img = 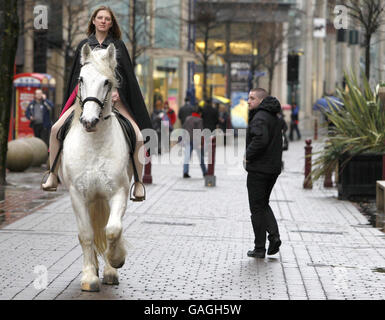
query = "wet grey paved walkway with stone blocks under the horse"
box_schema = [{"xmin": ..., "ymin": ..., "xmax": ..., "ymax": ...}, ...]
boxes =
[{"xmin": 0, "ymin": 134, "xmax": 385, "ymax": 300}]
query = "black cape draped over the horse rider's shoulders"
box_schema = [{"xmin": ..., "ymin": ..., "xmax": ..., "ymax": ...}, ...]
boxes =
[{"xmin": 62, "ymin": 34, "xmax": 152, "ymax": 130}]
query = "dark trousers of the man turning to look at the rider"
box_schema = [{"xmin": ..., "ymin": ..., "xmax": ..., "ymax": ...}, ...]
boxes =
[{"xmin": 247, "ymin": 172, "xmax": 279, "ymax": 251}]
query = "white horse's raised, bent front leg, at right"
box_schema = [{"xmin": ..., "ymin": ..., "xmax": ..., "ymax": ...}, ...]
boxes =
[{"xmin": 106, "ymin": 188, "xmax": 127, "ymax": 268}]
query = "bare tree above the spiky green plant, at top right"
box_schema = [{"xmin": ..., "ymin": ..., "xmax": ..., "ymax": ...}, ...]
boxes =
[{"xmin": 342, "ymin": 0, "xmax": 385, "ymax": 79}]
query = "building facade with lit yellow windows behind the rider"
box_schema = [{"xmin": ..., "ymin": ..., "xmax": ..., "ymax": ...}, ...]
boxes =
[{"xmin": 16, "ymin": 0, "xmax": 385, "ymax": 128}]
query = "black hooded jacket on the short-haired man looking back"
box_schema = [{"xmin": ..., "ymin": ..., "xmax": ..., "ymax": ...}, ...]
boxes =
[{"xmin": 246, "ymin": 97, "xmax": 282, "ymax": 174}]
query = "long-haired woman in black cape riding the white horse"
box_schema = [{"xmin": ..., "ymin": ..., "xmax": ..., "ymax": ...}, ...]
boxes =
[{"xmin": 42, "ymin": 6, "xmax": 152, "ymax": 201}]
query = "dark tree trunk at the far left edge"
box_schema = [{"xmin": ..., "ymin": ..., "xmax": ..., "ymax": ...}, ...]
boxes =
[{"xmin": 0, "ymin": 0, "xmax": 19, "ymax": 185}]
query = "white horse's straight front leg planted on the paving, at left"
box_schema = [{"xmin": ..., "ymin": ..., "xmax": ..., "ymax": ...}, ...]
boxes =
[{"xmin": 69, "ymin": 187, "xmax": 100, "ymax": 291}]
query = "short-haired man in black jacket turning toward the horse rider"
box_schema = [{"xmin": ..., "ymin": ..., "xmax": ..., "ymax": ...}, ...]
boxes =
[{"xmin": 245, "ymin": 89, "xmax": 282, "ymax": 259}]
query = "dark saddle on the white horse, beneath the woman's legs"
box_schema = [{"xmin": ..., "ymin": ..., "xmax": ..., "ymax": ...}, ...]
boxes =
[{"xmin": 50, "ymin": 109, "xmax": 140, "ymax": 183}]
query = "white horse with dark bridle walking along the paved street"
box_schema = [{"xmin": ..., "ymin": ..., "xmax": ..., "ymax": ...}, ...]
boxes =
[{"xmin": 60, "ymin": 44, "xmax": 132, "ymax": 291}]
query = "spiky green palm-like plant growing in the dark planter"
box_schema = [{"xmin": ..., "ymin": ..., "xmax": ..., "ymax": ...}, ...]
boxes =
[{"xmin": 312, "ymin": 74, "xmax": 385, "ymax": 180}]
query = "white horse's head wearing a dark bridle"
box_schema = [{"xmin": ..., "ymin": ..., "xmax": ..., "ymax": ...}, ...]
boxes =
[{"xmin": 79, "ymin": 43, "xmax": 117, "ymax": 132}]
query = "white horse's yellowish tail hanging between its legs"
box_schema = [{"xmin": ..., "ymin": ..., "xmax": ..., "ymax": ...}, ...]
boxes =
[{"xmin": 89, "ymin": 200, "xmax": 110, "ymax": 255}]
